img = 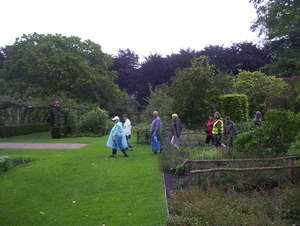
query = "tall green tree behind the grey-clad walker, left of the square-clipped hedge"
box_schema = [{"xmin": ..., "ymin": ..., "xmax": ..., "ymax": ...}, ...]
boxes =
[{"xmin": 170, "ymin": 56, "xmax": 221, "ymax": 126}]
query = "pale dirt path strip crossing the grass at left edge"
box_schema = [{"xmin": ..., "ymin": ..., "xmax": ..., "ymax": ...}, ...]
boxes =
[{"xmin": 0, "ymin": 142, "xmax": 88, "ymax": 149}]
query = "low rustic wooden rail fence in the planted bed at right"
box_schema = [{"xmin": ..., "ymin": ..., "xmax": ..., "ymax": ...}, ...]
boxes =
[{"xmin": 182, "ymin": 156, "xmax": 300, "ymax": 187}]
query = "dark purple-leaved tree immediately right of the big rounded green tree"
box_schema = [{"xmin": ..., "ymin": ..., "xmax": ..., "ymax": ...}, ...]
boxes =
[{"xmin": 109, "ymin": 49, "xmax": 140, "ymax": 95}]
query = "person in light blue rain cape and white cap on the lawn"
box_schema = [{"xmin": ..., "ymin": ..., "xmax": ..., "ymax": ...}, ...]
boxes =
[{"xmin": 106, "ymin": 116, "xmax": 128, "ymax": 157}]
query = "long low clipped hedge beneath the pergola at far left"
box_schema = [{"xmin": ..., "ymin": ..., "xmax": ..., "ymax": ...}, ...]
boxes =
[{"xmin": 0, "ymin": 123, "xmax": 51, "ymax": 138}]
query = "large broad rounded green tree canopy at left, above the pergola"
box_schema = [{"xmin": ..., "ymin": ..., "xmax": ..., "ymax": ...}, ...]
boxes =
[{"xmin": 0, "ymin": 33, "xmax": 120, "ymax": 110}]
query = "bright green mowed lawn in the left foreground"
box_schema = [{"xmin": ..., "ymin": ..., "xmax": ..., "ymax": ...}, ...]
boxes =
[{"xmin": 0, "ymin": 133, "xmax": 166, "ymax": 226}]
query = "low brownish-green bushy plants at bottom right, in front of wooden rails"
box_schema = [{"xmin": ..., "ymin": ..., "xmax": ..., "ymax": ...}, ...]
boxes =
[{"xmin": 166, "ymin": 188, "xmax": 285, "ymax": 226}]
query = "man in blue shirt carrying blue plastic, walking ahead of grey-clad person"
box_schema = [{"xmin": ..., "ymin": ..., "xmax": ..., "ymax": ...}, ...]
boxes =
[{"xmin": 151, "ymin": 111, "xmax": 162, "ymax": 154}]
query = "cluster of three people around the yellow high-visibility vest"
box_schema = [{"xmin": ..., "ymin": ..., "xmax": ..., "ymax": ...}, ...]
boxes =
[{"xmin": 205, "ymin": 112, "xmax": 238, "ymax": 149}]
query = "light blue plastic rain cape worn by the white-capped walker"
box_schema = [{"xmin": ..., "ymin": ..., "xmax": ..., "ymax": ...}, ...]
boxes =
[{"xmin": 106, "ymin": 122, "xmax": 128, "ymax": 150}]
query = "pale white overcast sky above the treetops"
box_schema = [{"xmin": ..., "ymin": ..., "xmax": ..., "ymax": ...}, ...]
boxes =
[{"xmin": 0, "ymin": 0, "xmax": 258, "ymax": 59}]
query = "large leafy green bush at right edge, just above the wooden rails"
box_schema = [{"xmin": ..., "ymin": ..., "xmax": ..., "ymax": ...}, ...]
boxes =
[{"xmin": 235, "ymin": 110, "xmax": 300, "ymax": 157}]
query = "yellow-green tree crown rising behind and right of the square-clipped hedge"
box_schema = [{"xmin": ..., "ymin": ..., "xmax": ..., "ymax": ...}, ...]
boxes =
[{"xmin": 233, "ymin": 71, "xmax": 287, "ymax": 115}]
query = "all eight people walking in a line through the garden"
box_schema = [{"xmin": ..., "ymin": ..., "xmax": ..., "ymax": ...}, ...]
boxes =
[{"xmin": 106, "ymin": 111, "xmax": 262, "ymax": 157}]
